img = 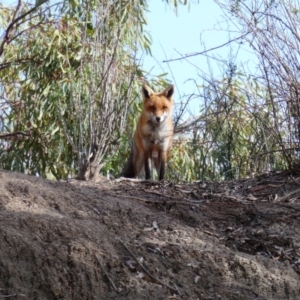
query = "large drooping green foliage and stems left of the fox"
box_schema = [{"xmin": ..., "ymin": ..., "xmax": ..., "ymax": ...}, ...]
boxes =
[{"xmin": 0, "ymin": 1, "xmax": 150, "ymax": 179}]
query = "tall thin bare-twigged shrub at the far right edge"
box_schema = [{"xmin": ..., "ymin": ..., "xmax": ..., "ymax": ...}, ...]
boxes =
[{"xmin": 215, "ymin": 0, "xmax": 300, "ymax": 168}]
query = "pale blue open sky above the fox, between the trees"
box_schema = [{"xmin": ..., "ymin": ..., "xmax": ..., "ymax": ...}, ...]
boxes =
[{"xmin": 143, "ymin": 0, "xmax": 255, "ymax": 114}]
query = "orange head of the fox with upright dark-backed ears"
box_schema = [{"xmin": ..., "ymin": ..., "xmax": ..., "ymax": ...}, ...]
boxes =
[{"xmin": 142, "ymin": 84, "xmax": 174, "ymax": 124}]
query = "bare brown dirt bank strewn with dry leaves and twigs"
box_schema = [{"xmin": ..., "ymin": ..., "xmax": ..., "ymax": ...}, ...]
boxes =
[{"xmin": 0, "ymin": 171, "xmax": 300, "ymax": 300}]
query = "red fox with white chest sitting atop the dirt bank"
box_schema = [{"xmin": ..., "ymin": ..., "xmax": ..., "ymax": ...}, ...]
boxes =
[{"xmin": 122, "ymin": 85, "xmax": 174, "ymax": 180}]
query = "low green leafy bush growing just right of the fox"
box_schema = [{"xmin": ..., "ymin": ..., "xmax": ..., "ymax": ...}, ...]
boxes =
[{"xmin": 168, "ymin": 74, "xmax": 288, "ymax": 181}]
